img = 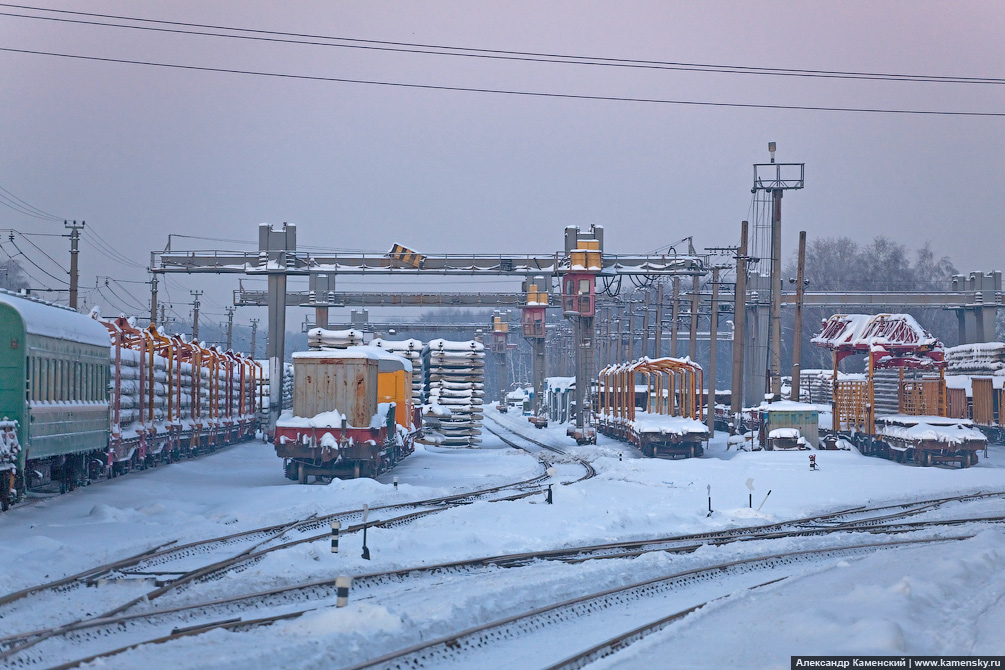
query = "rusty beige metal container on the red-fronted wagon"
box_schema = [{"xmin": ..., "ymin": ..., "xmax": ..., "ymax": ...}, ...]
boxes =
[{"xmin": 293, "ymin": 350, "xmax": 380, "ymax": 428}]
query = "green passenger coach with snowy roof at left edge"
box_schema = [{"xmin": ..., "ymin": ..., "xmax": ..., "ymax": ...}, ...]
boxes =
[{"xmin": 0, "ymin": 291, "xmax": 110, "ymax": 493}]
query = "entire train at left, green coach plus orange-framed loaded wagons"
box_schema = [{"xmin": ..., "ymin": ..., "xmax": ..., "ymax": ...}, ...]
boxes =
[{"xmin": 0, "ymin": 290, "xmax": 260, "ymax": 507}]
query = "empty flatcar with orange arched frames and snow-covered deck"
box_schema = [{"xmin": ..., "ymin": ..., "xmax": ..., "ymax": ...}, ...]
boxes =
[{"xmin": 597, "ymin": 358, "xmax": 709, "ymax": 457}]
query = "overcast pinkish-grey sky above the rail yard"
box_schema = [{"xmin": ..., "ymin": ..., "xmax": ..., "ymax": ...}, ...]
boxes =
[{"xmin": 0, "ymin": 0, "xmax": 1005, "ymax": 323}]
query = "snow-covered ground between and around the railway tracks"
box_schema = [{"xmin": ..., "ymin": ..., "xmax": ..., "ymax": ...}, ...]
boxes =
[{"xmin": 0, "ymin": 411, "xmax": 1005, "ymax": 668}]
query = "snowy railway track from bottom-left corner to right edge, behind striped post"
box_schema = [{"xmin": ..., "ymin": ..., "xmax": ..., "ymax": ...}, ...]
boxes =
[{"xmin": 0, "ymin": 494, "xmax": 1005, "ymax": 667}]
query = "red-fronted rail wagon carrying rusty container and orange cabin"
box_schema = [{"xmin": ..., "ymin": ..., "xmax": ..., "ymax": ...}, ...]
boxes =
[{"xmin": 273, "ymin": 346, "xmax": 420, "ymax": 484}]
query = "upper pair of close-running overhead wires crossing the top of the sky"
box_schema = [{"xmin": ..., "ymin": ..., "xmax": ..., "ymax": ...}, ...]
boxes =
[{"xmin": 0, "ymin": 3, "xmax": 1005, "ymax": 85}]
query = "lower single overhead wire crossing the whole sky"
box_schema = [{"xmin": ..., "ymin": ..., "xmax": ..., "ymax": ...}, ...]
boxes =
[{"xmin": 0, "ymin": 47, "xmax": 1005, "ymax": 118}]
